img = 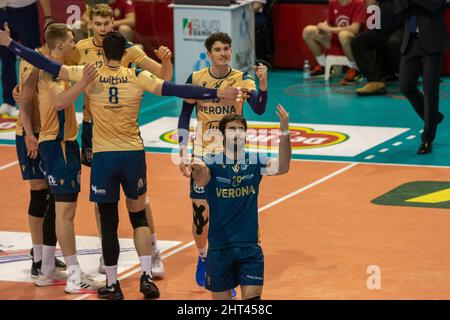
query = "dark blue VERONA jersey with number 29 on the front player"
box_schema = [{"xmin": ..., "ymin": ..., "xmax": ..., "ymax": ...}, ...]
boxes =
[{"xmin": 205, "ymin": 153, "xmax": 265, "ymax": 249}]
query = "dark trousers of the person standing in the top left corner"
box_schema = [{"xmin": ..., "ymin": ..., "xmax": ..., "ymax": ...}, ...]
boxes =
[{"xmin": 0, "ymin": 3, "xmax": 40, "ymax": 105}]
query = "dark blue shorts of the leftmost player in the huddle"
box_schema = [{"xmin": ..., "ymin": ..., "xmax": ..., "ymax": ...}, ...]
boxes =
[{"xmin": 16, "ymin": 133, "xmax": 45, "ymax": 180}]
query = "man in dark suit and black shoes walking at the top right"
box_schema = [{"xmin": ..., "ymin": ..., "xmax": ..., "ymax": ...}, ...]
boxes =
[{"xmin": 395, "ymin": 0, "xmax": 448, "ymax": 154}]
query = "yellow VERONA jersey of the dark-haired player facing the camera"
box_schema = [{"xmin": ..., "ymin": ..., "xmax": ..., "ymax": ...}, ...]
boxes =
[{"xmin": 186, "ymin": 68, "xmax": 256, "ymax": 156}]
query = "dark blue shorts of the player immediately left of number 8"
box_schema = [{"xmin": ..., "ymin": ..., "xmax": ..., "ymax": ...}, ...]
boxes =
[{"xmin": 39, "ymin": 140, "xmax": 81, "ymax": 194}]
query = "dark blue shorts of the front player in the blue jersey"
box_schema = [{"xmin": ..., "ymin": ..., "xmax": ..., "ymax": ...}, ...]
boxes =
[{"xmin": 205, "ymin": 245, "xmax": 264, "ymax": 292}]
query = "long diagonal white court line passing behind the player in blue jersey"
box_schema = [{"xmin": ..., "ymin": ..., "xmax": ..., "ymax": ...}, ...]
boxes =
[{"xmin": 74, "ymin": 163, "xmax": 358, "ymax": 300}]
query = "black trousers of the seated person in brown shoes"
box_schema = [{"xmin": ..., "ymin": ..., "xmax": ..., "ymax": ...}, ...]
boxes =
[{"xmin": 351, "ymin": 26, "xmax": 403, "ymax": 81}]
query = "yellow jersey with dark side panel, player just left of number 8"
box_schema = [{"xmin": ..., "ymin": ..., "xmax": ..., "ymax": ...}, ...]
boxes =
[{"xmin": 38, "ymin": 70, "xmax": 78, "ymax": 142}]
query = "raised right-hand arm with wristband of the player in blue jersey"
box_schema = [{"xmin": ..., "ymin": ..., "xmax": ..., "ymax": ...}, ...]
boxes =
[{"xmin": 265, "ymin": 104, "xmax": 292, "ymax": 176}]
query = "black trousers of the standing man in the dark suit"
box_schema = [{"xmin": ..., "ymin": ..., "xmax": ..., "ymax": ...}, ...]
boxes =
[{"xmin": 400, "ymin": 36, "xmax": 443, "ymax": 142}]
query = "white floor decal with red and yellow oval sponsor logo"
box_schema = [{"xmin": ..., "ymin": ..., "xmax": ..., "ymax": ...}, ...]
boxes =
[{"xmin": 134, "ymin": 117, "xmax": 410, "ymax": 157}]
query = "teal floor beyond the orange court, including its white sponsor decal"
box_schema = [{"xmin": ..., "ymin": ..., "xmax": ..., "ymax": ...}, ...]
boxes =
[{"xmin": 0, "ymin": 70, "xmax": 450, "ymax": 166}]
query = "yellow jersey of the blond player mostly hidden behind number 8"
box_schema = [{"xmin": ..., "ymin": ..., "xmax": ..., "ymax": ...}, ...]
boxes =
[{"xmin": 68, "ymin": 37, "xmax": 147, "ymax": 122}]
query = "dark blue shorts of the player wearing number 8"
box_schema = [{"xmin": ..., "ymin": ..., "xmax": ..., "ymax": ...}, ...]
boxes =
[{"xmin": 90, "ymin": 150, "xmax": 147, "ymax": 203}]
